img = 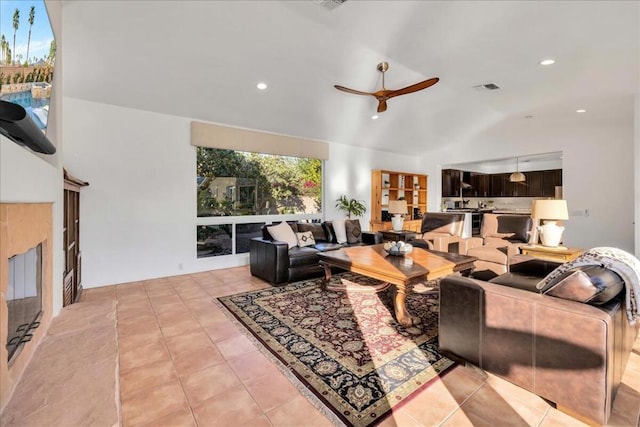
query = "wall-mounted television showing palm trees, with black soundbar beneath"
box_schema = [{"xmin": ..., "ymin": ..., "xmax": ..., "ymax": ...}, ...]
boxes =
[{"xmin": 0, "ymin": 0, "xmax": 56, "ymax": 154}]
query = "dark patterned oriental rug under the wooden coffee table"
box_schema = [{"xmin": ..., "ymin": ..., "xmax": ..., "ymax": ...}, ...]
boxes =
[{"xmin": 218, "ymin": 272, "xmax": 454, "ymax": 426}]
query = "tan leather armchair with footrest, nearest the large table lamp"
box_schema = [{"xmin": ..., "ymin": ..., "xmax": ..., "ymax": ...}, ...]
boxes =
[{"xmin": 459, "ymin": 213, "xmax": 534, "ymax": 280}]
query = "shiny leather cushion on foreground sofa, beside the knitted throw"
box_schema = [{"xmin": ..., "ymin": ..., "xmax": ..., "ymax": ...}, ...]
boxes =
[{"xmin": 543, "ymin": 265, "xmax": 624, "ymax": 305}]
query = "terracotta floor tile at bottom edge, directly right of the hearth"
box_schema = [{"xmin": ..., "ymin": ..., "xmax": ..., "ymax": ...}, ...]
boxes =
[{"xmin": 122, "ymin": 381, "xmax": 189, "ymax": 426}]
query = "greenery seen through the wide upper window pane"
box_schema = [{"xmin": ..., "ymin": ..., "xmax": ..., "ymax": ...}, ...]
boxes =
[{"xmin": 197, "ymin": 147, "xmax": 322, "ymax": 217}]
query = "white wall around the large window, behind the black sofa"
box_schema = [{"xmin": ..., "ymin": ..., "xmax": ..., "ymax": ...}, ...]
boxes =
[{"xmin": 63, "ymin": 97, "xmax": 418, "ymax": 288}]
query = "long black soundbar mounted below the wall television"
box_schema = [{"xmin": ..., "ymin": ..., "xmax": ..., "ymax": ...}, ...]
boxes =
[{"xmin": 0, "ymin": 101, "xmax": 56, "ymax": 154}]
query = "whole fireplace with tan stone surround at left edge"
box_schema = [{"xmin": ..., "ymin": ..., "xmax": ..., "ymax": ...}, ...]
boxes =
[{"xmin": 0, "ymin": 203, "xmax": 53, "ymax": 412}]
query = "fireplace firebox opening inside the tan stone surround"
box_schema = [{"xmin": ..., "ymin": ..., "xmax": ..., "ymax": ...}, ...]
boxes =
[{"xmin": 6, "ymin": 243, "xmax": 42, "ymax": 364}]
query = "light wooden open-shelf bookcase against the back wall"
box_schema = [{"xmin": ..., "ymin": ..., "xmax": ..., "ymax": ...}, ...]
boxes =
[{"xmin": 370, "ymin": 170, "xmax": 428, "ymax": 232}]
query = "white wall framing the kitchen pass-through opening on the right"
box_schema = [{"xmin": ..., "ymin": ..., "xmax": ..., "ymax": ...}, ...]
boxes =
[{"xmin": 422, "ymin": 113, "xmax": 634, "ymax": 253}]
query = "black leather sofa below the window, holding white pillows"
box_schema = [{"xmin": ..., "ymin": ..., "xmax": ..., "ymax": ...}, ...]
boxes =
[{"xmin": 249, "ymin": 219, "xmax": 382, "ymax": 285}]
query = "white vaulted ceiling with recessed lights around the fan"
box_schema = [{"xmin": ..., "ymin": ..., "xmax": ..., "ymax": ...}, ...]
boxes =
[{"xmin": 62, "ymin": 0, "xmax": 640, "ymax": 154}]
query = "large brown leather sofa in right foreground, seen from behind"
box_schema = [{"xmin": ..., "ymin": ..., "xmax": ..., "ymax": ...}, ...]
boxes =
[{"xmin": 439, "ymin": 256, "xmax": 639, "ymax": 424}]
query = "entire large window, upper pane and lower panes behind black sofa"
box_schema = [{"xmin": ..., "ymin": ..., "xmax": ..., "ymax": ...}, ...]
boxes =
[{"xmin": 196, "ymin": 147, "xmax": 322, "ymax": 258}]
